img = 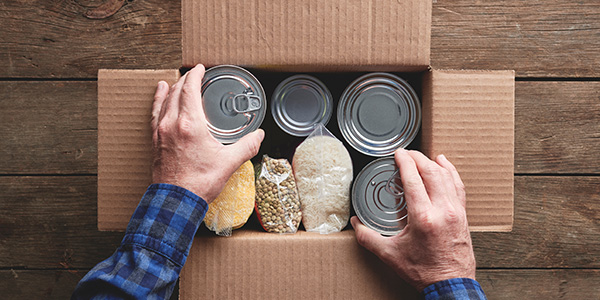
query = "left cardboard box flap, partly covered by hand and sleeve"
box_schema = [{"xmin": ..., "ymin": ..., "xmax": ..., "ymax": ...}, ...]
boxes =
[{"xmin": 98, "ymin": 70, "xmax": 179, "ymax": 230}]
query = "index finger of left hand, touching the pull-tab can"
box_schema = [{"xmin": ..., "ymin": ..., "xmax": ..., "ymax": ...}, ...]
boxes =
[{"xmin": 179, "ymin": 65, "xmax": 205, "ymax": 119}]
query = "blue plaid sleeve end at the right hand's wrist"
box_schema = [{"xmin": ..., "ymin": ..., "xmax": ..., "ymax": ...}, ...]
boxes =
[{"xmin": 422, "ymin": 278, "xmax": 487, "ymax": 300}]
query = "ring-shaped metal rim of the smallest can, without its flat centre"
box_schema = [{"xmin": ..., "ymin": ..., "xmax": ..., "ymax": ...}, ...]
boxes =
[{"xmin": 271, "ymin": 74, "xmax": 333, "ymax": 137}]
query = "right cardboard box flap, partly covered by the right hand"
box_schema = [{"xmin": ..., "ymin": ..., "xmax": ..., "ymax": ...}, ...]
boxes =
[{"xmin": 422, "ymin": 70, "xmax": 515, "ymax": 231}]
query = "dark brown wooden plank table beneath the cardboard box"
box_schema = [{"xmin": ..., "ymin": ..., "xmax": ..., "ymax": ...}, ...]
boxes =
[{"xmin": 0, "ymin": 0, "xmax": 600, "ymax": 299}]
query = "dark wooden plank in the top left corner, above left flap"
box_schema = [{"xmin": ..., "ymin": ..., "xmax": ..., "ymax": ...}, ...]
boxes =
[{"xmin": 0, "ymin": 0, "xmax": 181, "ymax": 78}]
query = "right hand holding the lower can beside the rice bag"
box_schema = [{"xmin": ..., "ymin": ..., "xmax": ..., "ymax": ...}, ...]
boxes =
[{"xmin": 351, "ymin": 149, "xmax": 475, "ymax": 291}]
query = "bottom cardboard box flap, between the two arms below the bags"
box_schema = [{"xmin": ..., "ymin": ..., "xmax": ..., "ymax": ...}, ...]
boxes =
[{"xmin": 179, "ymin": 230, "xmax": 417, "ymax": 299}]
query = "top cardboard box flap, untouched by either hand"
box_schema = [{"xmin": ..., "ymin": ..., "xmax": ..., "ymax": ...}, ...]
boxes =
[{"xmin": 181, "ymin": 0, "xmax": 432, "ymax": 71}]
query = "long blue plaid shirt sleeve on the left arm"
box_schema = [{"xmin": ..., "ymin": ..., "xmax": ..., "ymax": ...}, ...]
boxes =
[{"xmin": 71, "ymin": 184, "xmax": 208, "ymax": 299}]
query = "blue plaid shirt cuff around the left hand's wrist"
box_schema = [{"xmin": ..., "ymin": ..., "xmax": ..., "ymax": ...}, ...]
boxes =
[{"xmin": 121, "ymin": 183, "xmax": 208, "ymax": 266}]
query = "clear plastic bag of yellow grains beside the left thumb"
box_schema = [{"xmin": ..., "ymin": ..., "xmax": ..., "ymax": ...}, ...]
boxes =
[{"xmin": 204, "ymin": 161, "xmax": 255, "ymax": 236}]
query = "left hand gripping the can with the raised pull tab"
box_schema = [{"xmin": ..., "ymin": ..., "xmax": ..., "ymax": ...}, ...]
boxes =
[{"xmin": 151, "ymin": 65, "xmax": 265, "ymax": 203}]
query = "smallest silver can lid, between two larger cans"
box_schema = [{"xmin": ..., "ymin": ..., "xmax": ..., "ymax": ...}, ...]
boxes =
[{"xmin": 271, "ymin": 75, "xmax": 333, "ymax": 136}]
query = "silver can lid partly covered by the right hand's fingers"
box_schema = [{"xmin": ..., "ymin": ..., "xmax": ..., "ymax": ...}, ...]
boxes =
[{"xmin": 352, "ymin": 157, "xmax": 408, "ymax": 235}]
